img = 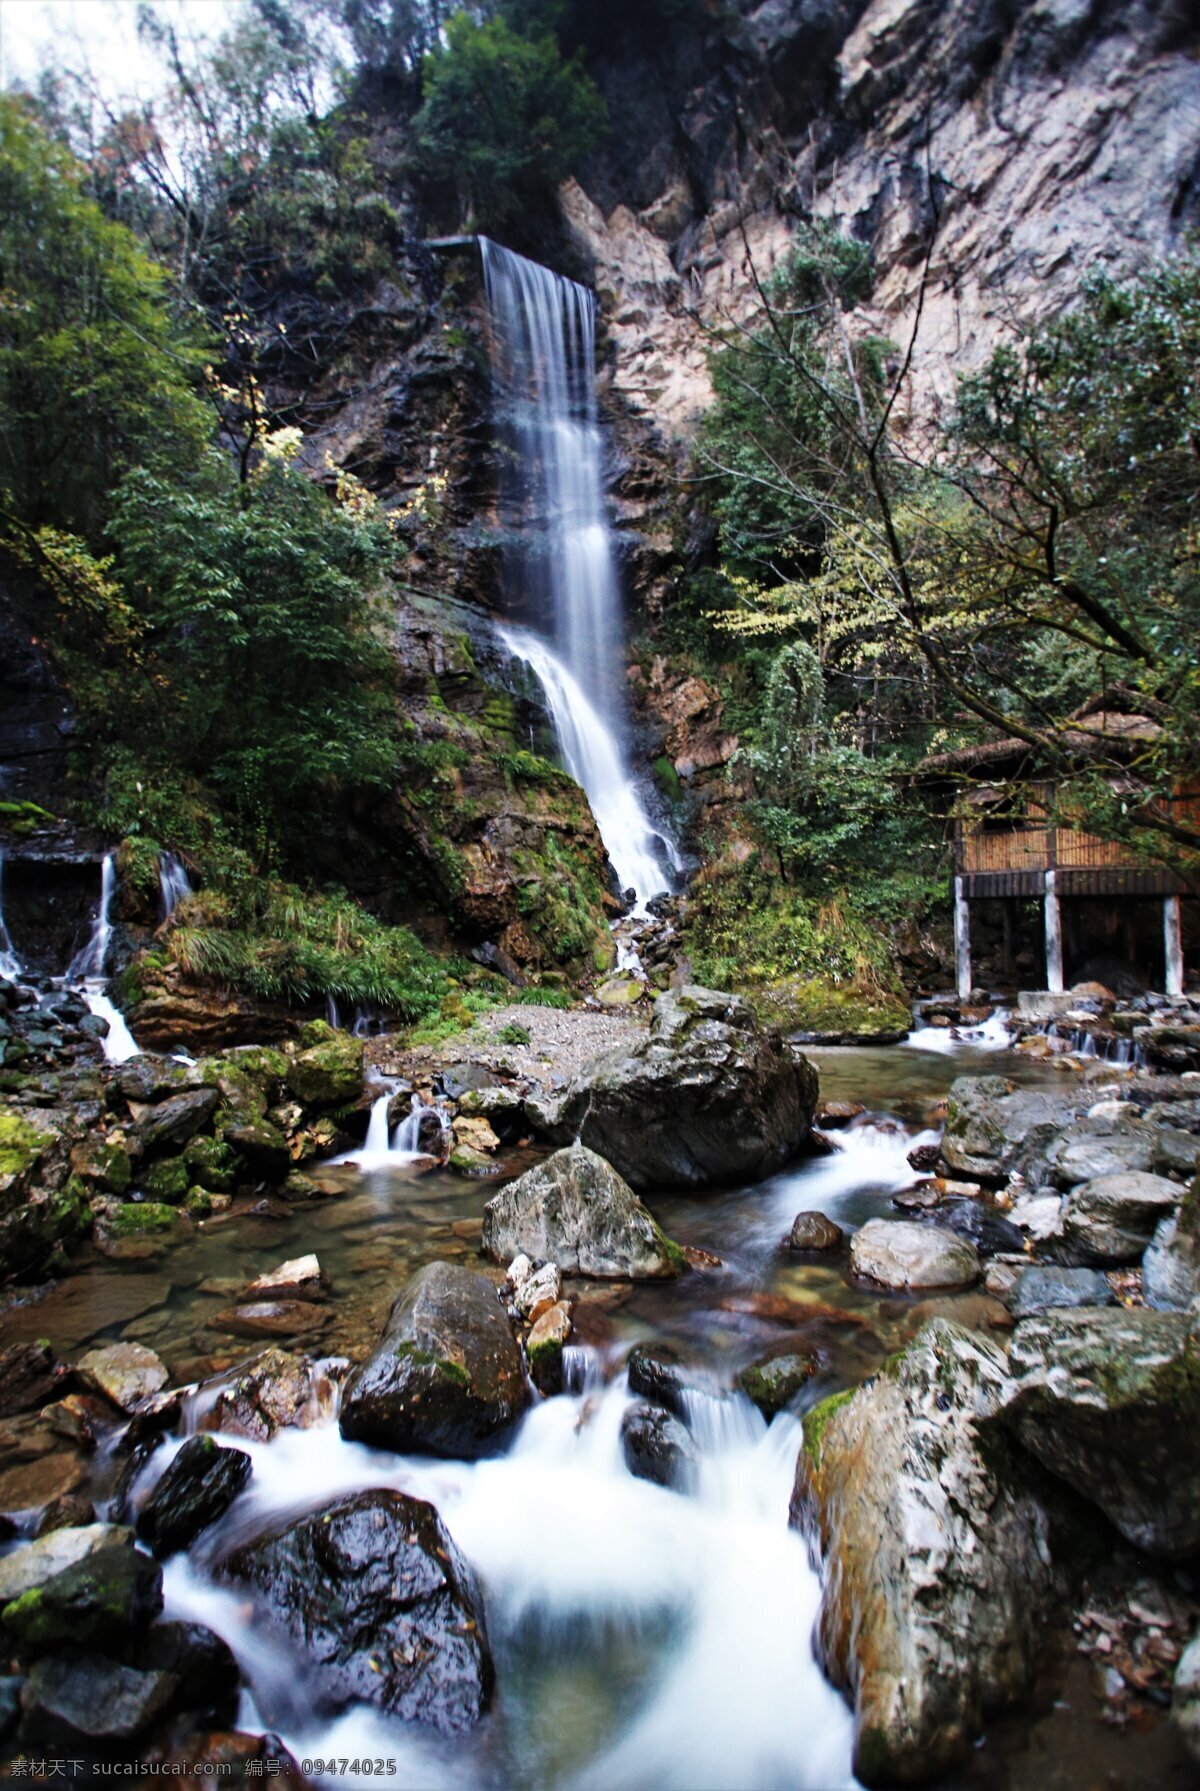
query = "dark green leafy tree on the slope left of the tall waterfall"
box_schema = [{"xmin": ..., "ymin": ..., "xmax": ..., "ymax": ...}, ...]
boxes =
[{"xmin": 95, "ymin": 455, "xmax": 394, "ymax": 853}]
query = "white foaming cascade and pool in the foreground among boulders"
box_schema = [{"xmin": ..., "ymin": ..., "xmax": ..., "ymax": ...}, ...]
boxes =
[{"xmin": 167, "ymin": 1381, "xmax": 853, "ymax": 1791}]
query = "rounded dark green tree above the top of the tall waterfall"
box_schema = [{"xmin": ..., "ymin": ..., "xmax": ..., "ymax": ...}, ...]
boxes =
[{"xmin": 414, "ymin": 13, "xmax": 607, "ymax": 229}]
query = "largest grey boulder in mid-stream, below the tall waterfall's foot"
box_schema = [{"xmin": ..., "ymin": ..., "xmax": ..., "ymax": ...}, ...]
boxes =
[{"xmin": 525, "ymin": 987, "xmax": 817, "ymax": 1189}]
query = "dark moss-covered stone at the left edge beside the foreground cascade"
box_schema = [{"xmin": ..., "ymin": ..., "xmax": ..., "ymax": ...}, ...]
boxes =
[{"xmin": 0, "ymin": 1546, "xmax": 163, "ymax": 1653}]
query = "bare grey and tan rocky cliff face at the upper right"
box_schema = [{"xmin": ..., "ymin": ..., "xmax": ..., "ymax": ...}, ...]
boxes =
[{"xmin": 562, "ymin": 0, "xmax": 1200, "ymax": 437}]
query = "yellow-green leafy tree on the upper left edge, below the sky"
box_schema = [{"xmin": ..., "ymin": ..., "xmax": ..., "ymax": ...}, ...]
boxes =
[{"xmin": 0, "ymin": 95, "xmax": 211, "ymax": 537}]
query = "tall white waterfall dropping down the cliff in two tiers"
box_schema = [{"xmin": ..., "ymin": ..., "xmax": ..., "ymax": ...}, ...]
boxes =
[{"xmin": 480, "ymin": 236, "xmax": 679, "ymax": 903}]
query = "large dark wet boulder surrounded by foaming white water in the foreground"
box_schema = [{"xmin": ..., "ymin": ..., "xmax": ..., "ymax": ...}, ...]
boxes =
[{"xmin": 217, "ymin": 1488, "xmax": 494, "ymax": 1735}]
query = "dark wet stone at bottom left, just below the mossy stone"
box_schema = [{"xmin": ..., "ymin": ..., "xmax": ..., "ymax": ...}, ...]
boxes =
[{"xmin": 20, "ymin": 1650, "xmax": 179, "ymax": 1752}]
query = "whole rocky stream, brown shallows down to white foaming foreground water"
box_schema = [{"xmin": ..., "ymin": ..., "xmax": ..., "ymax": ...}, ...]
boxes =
[{"xmin": 0, "ymin": 1044, "xmax": 1182, "ymax": 1791}]
